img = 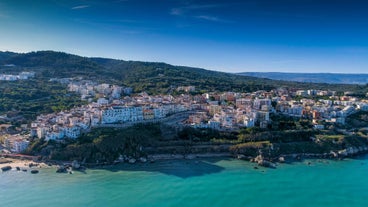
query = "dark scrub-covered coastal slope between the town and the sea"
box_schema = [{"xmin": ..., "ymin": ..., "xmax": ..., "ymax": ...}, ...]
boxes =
[{"xmin": 23, "ymin": 121, "xmax": 368, "ymax": 163}]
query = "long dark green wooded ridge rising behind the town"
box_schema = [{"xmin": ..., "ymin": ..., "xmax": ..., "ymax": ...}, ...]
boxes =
[{"xmin": 0, "ymin": 51, "xmax": 366, "ymax": 94}]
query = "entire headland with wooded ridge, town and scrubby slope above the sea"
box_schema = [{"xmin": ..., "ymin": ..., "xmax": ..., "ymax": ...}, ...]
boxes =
[{"xmin": 0, "ymin": 51, "xmax": 368, "ymax": 170}]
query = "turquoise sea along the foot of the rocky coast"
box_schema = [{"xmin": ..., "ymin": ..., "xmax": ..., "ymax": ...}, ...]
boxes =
[{"xmin": 0, "ymin": 156, "xmax": 368, "ymax": 207}]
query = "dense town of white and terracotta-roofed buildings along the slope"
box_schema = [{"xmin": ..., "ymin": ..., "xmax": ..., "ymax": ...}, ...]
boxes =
[{"xmin": 2, "ymin": 78, "xmax": 368, "ymax": 158}]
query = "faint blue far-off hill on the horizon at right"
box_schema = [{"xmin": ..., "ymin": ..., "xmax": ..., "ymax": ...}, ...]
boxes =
[{"xmin": 239, "ymin": 72, "xmax": 368, "ymax": 84}]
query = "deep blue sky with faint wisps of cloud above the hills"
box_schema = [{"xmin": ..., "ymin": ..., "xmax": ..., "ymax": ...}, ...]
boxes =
[{"xmin": 0, "ymin": 0, "xmax": 368, "ymax": 73}]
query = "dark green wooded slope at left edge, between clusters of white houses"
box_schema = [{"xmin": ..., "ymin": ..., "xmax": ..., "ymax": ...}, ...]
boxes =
[{"xmin": 0, "ymin": 79, "xmax": 83, "ymax": 124}]
